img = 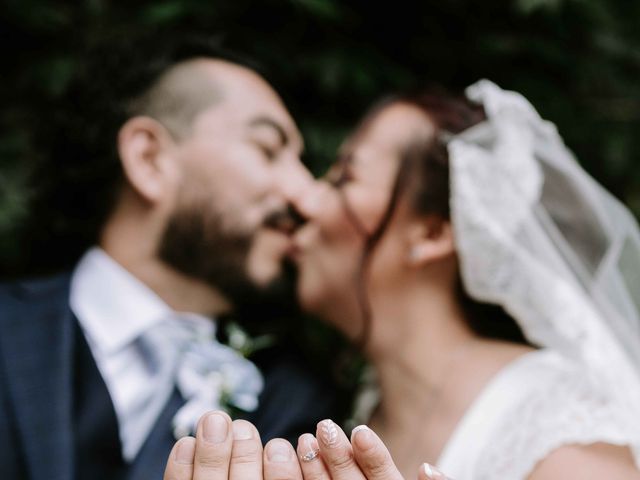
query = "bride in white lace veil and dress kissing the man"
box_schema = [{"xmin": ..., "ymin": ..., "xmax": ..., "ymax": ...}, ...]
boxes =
[{"xmin": 162, "ymin": 81, "xmax": 640, "ymax": 480}]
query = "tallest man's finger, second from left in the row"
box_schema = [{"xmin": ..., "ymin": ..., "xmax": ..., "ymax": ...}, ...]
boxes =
[{"xmin": 193, "ymin": 412, "xmax": 233, "ymax": 480}]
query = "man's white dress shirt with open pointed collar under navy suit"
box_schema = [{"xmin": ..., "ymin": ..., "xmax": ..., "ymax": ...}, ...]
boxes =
[{"xmin": 70, "ymin": 248, "xmax": 215, "ymax": 462}]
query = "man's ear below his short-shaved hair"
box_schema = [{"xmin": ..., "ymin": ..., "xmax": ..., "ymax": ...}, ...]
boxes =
[{"xmin": 118, "ymin": 117, "xmax": 173, "ymax": 203}]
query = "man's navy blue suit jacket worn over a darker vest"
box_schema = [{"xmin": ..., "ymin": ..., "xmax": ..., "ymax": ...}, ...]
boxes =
[{"xmin": 0, "ymin": 275, "xmax": 335, "ymax": 480}]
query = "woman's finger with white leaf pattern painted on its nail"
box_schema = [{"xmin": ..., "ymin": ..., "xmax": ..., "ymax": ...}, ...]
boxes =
[{"xmin": 316, "ymin": 420, "xmax": 365, "ymax": 480}]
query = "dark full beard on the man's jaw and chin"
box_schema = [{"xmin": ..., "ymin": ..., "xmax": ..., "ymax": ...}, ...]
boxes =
[{"xmin": 158, "ymin": 199, "xmax": 298, "ymax": 327}]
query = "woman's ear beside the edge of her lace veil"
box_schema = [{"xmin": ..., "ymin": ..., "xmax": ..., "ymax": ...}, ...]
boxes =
[{"xmin": 407, "ymin": 215, "xmax": 455, "ymax": 267}]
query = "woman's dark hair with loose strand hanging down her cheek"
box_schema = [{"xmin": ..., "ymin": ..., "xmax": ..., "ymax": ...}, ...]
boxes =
[{"xmin": 343, "ymin": 88, "xmax": 528, "ymax": 346}]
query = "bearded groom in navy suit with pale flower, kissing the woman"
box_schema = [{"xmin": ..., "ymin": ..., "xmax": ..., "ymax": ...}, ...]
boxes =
[{"xmin": 0, "ymin": 34, "xmax": 332, "ymax": 480}]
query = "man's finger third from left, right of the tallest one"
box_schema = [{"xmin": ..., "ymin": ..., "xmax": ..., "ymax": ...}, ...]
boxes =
[{"xmin": 229, "ymin": 420, "xmax": 262, "ymax": 480}]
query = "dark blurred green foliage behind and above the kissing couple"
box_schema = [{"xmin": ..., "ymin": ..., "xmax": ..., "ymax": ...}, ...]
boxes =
[{"xmin": 0, "ymin": 0, "xmax": 640, "ymax": 278}]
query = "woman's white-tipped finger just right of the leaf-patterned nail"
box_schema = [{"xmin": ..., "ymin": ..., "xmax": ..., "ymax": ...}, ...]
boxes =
[{"xmin": 351, "ymin": 425, "xmax": 402, "ymax": 480}]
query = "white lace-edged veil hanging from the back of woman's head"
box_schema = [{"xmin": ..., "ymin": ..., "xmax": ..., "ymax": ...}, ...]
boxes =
[{"xmin": 448, "ymin": 80, "xmax": 640, "ymax": 420}]
